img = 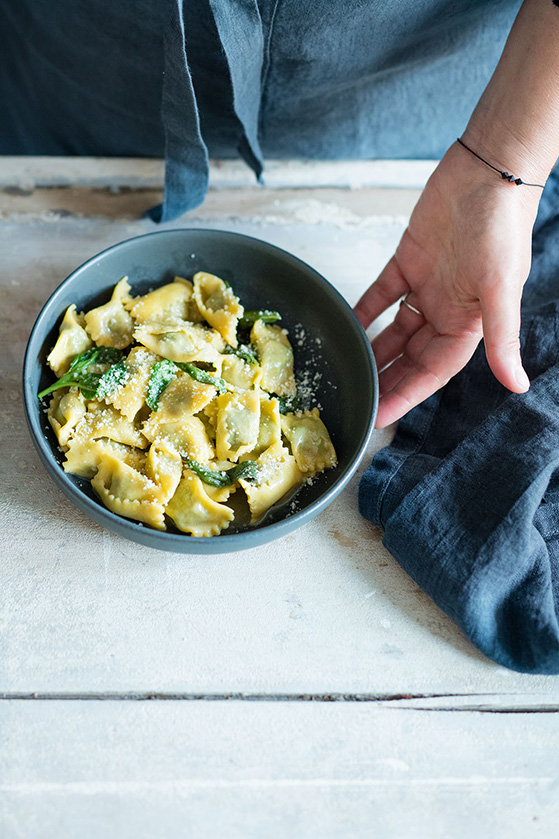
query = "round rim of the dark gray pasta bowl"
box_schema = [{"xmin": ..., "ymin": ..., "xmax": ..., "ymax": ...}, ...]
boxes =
[{"xmin": 22, "ymin": 227, "xmax": 379, "ymax": 553}]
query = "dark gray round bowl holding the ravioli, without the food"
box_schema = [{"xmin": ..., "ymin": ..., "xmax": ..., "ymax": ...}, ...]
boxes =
[{"xmin": 23, "ymin": 230, "xmax": 378, "ymax": 554}]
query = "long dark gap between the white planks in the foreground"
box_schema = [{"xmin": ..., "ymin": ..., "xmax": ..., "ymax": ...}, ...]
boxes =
[{"xmin": 0, "ymin": 691, "xmax": 559, "ymax": 714}]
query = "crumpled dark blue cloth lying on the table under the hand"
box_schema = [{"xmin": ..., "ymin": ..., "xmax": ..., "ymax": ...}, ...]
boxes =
[{"xmin": 359, "ymin": 167, "xmax": 559, "ymax": 674}]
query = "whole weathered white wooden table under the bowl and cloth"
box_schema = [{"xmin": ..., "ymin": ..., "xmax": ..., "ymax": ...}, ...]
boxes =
[{"xmin": 0, "ymin": 159, "xmax": 559, "ymax": 839}]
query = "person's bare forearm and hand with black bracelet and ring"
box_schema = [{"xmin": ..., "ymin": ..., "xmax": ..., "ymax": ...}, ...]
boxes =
[{"xmin": 355, "ymin": 0, "xmax": 559, "ymax": 427}]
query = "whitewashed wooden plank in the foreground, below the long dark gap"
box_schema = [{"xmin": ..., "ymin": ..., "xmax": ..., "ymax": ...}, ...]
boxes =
[{"xmin": 0, "ymin": 701, "xmax": 559, "ymax": 839}]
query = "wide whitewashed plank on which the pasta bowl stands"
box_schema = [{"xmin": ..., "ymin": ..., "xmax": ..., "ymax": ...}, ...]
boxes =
[{"xmin": 0, "ymin": 213, "xmax": 557, "ymax": 696}]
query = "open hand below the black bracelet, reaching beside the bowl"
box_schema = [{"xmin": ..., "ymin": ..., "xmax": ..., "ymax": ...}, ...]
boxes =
[{"xmin": 355, "ymin": 144, "xmax": 541, "ymax": 428}]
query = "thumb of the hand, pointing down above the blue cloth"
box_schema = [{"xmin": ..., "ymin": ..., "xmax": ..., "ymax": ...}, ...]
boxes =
[{"xmin": 481, "ymin": 283, "xmax": 530, "ymax": 393}]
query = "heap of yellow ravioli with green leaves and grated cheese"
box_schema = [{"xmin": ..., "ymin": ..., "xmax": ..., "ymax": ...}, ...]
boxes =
[{"xmin": 42, "ymin": 272, "xmax": 337, "ymax": 537}]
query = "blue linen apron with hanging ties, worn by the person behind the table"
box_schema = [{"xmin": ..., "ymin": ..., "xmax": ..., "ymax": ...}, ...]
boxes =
[{"xmin": 0, "ymin": 0, "xmax": 520, "ymax": 221}]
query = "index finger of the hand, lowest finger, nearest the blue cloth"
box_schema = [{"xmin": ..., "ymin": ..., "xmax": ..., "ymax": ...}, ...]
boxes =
[{"xmin": 376, "ymin": 324, "xmax": 479, "ymax": 428}]
